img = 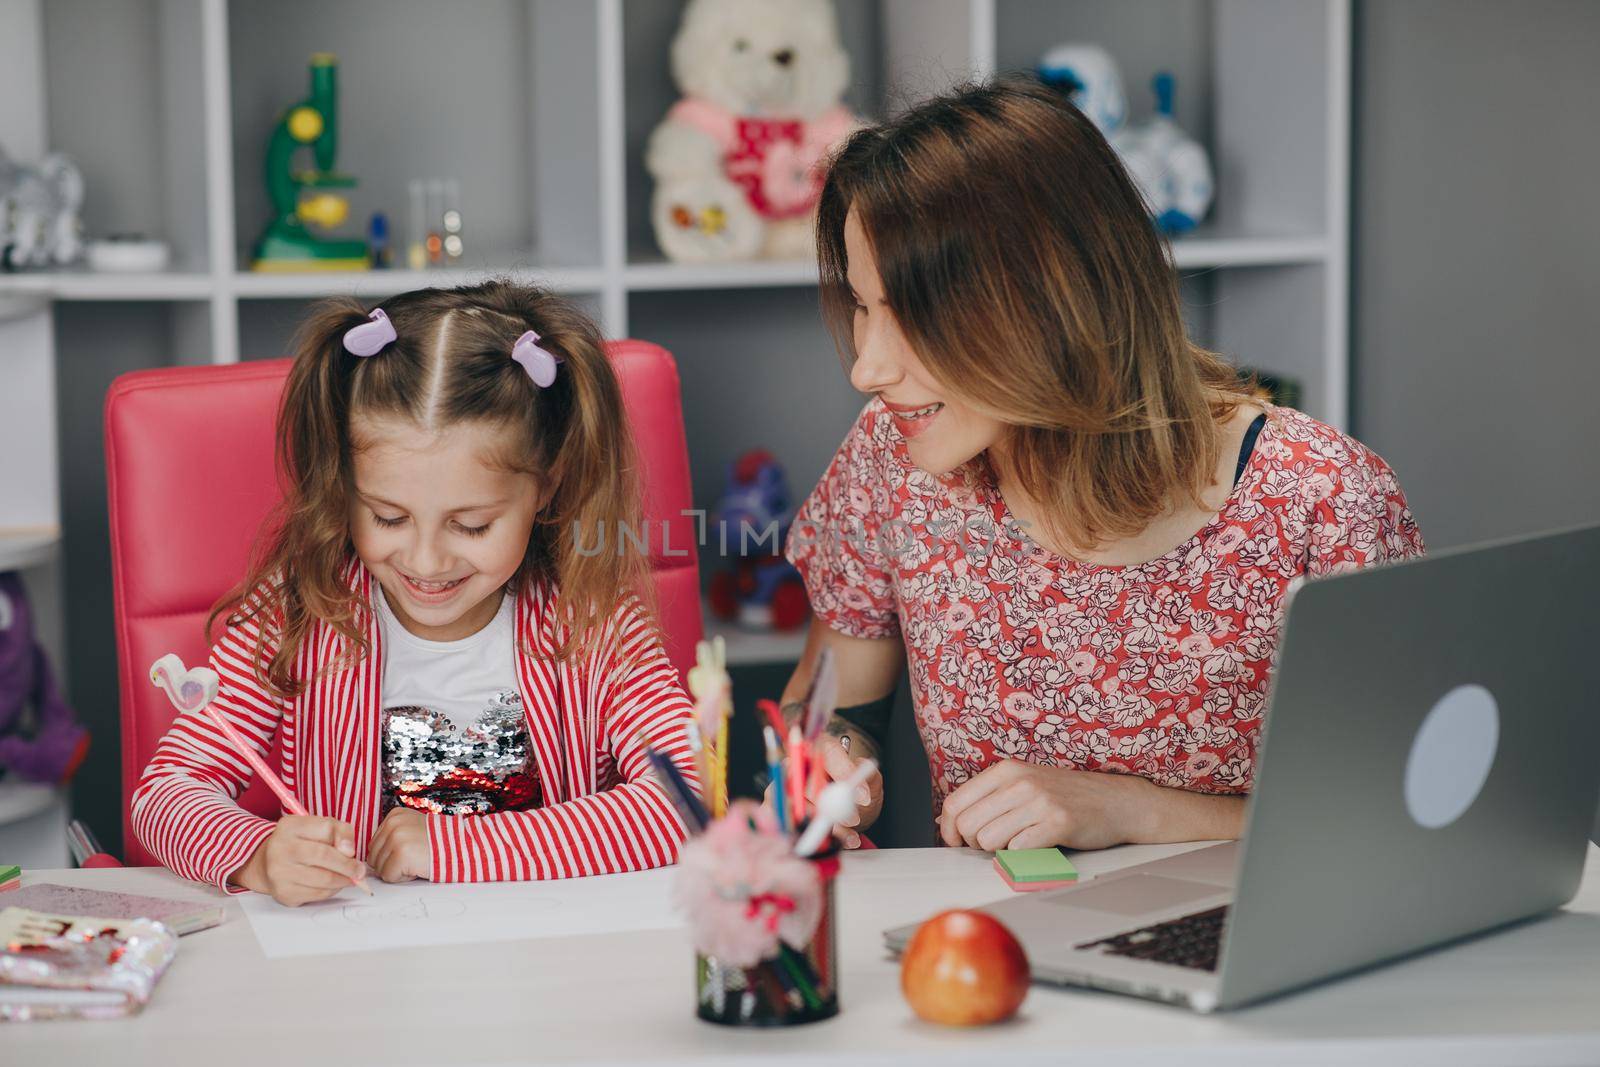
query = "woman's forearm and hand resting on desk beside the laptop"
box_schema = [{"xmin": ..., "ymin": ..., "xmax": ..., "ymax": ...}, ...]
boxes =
[{"xmin": 939, "ymin": 760, "xmax": 1245, "ymax": 851}]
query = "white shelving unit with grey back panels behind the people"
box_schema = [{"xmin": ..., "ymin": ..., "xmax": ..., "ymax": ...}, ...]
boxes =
[{"xmin": 0, "ymin": 0, "xmax": 1350, "ymax": 687}]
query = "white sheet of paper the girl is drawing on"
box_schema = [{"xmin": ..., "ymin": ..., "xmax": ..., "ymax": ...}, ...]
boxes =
[{"xmin": 238, "ymin": 867, "xmax": 683, "ymax": 958}]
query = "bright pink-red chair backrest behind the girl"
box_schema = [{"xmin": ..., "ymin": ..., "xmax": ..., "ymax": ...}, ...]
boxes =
[{"xmin": 106, "ymin": 341, "xmax": 701, "ymax": 865}]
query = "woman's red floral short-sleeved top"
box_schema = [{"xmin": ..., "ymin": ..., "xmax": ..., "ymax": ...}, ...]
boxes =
[{"xmin": 789, "ymin": 400, "xmax": 1422, "ymax": 814}]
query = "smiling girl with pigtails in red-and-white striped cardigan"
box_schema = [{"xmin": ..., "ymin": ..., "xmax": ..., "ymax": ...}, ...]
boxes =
[{"xmin": 133, "ymin": 282, "xmax": 694, "ymax": 905}]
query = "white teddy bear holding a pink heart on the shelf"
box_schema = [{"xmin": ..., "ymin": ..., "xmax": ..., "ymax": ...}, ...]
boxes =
[{"xmin": 645, "ymin": 0, "xmax": 856, "ymax": 262}]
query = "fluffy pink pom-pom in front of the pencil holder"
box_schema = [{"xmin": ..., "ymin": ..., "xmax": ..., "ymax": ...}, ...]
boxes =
[{"xmin": 674, "ymin": 800, "xmax": 822, "ymax": 968}]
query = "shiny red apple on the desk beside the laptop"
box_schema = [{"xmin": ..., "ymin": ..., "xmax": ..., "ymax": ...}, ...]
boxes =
[{"xmin": 901, "ymin": 910, "xmax": 1029, "ymax": 1027}]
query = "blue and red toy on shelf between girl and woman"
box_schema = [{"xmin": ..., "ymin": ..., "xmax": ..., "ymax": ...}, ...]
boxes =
[{"xmin": 709, "ymin": 450, "xmax": 810, "ymax": 630}]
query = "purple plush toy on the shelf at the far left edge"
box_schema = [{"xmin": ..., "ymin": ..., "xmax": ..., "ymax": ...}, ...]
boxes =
[{"xmin": 0, "ymin": 571, "xmax": 90, "ymax": 782}]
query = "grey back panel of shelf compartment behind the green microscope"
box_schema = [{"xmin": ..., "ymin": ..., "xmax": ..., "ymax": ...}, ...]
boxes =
[{"xmin": 229, "ymin": 0, "xmax": 600, "ymax": 271}]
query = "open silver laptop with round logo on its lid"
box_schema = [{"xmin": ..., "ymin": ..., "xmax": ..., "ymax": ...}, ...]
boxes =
[{"xmin": 885, "ymin": 526, "xmax": 1600, "ymax": 1011}]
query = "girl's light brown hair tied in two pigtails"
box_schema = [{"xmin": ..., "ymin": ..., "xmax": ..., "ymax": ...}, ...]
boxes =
[{"xmin": 206, "ymin": 282, "xmax": 651, "ymax": 696}]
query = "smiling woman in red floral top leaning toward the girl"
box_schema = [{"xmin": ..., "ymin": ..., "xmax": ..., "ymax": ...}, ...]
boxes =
[{"xmin": 784, "ymin": 83, "xmax": 1422, "ymax": 849}]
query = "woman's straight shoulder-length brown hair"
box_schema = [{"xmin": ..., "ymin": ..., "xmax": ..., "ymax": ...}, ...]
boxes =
[{"xmin": 818, "ymin": 80, "xmax": 1246, "ymax": 549}]
